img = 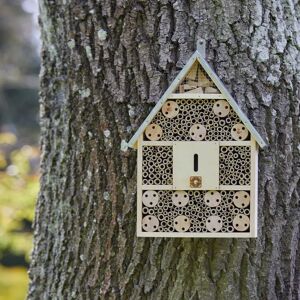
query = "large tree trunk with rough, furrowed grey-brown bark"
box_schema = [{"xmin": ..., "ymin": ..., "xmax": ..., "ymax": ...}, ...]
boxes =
[{"xmin": 28, "ymin": 0, "xmax": 300, "ymax": 300}]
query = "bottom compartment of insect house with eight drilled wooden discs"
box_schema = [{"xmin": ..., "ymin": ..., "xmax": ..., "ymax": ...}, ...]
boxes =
[{"xmin": 137, "ymin": 190, "xmax": 255, "ymax": 237}]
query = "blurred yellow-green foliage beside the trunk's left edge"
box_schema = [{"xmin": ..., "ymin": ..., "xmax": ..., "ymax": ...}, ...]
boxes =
[{"xmin": 0, "ymin": 133, "xmax": 39, "ymax": 265}]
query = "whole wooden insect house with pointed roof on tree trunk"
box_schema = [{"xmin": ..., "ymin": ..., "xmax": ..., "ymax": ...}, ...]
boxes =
[{"xmin": 128, "ymin": 50, "xmax": 265, "ymax": 237}]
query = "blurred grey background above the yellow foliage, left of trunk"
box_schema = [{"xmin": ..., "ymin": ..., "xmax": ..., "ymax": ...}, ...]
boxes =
[{"xmin": 0, "ymin": 0, "xmax": 39, "ymax": 143}]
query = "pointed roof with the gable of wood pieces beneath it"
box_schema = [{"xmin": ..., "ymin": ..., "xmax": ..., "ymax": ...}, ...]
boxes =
[{"xmin": 128, "ymin": 51, "xmax": 266, "ymax": 148}]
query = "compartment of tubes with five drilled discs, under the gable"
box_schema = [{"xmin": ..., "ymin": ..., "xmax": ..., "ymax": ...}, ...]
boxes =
[{"xmin": 144, "ymin": 99, "xmax": 250, "ymax": 141}]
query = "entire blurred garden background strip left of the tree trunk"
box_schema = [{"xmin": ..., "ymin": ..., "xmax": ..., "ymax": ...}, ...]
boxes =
[{"xmin": 0, "ymin": 0, "xmax": 40, "ymax": 300}]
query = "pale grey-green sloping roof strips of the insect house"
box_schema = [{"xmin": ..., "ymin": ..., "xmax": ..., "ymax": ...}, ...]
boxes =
[{"xmin": 128, "ymin": 50, "xmax": 267, "ymax": 148}]
